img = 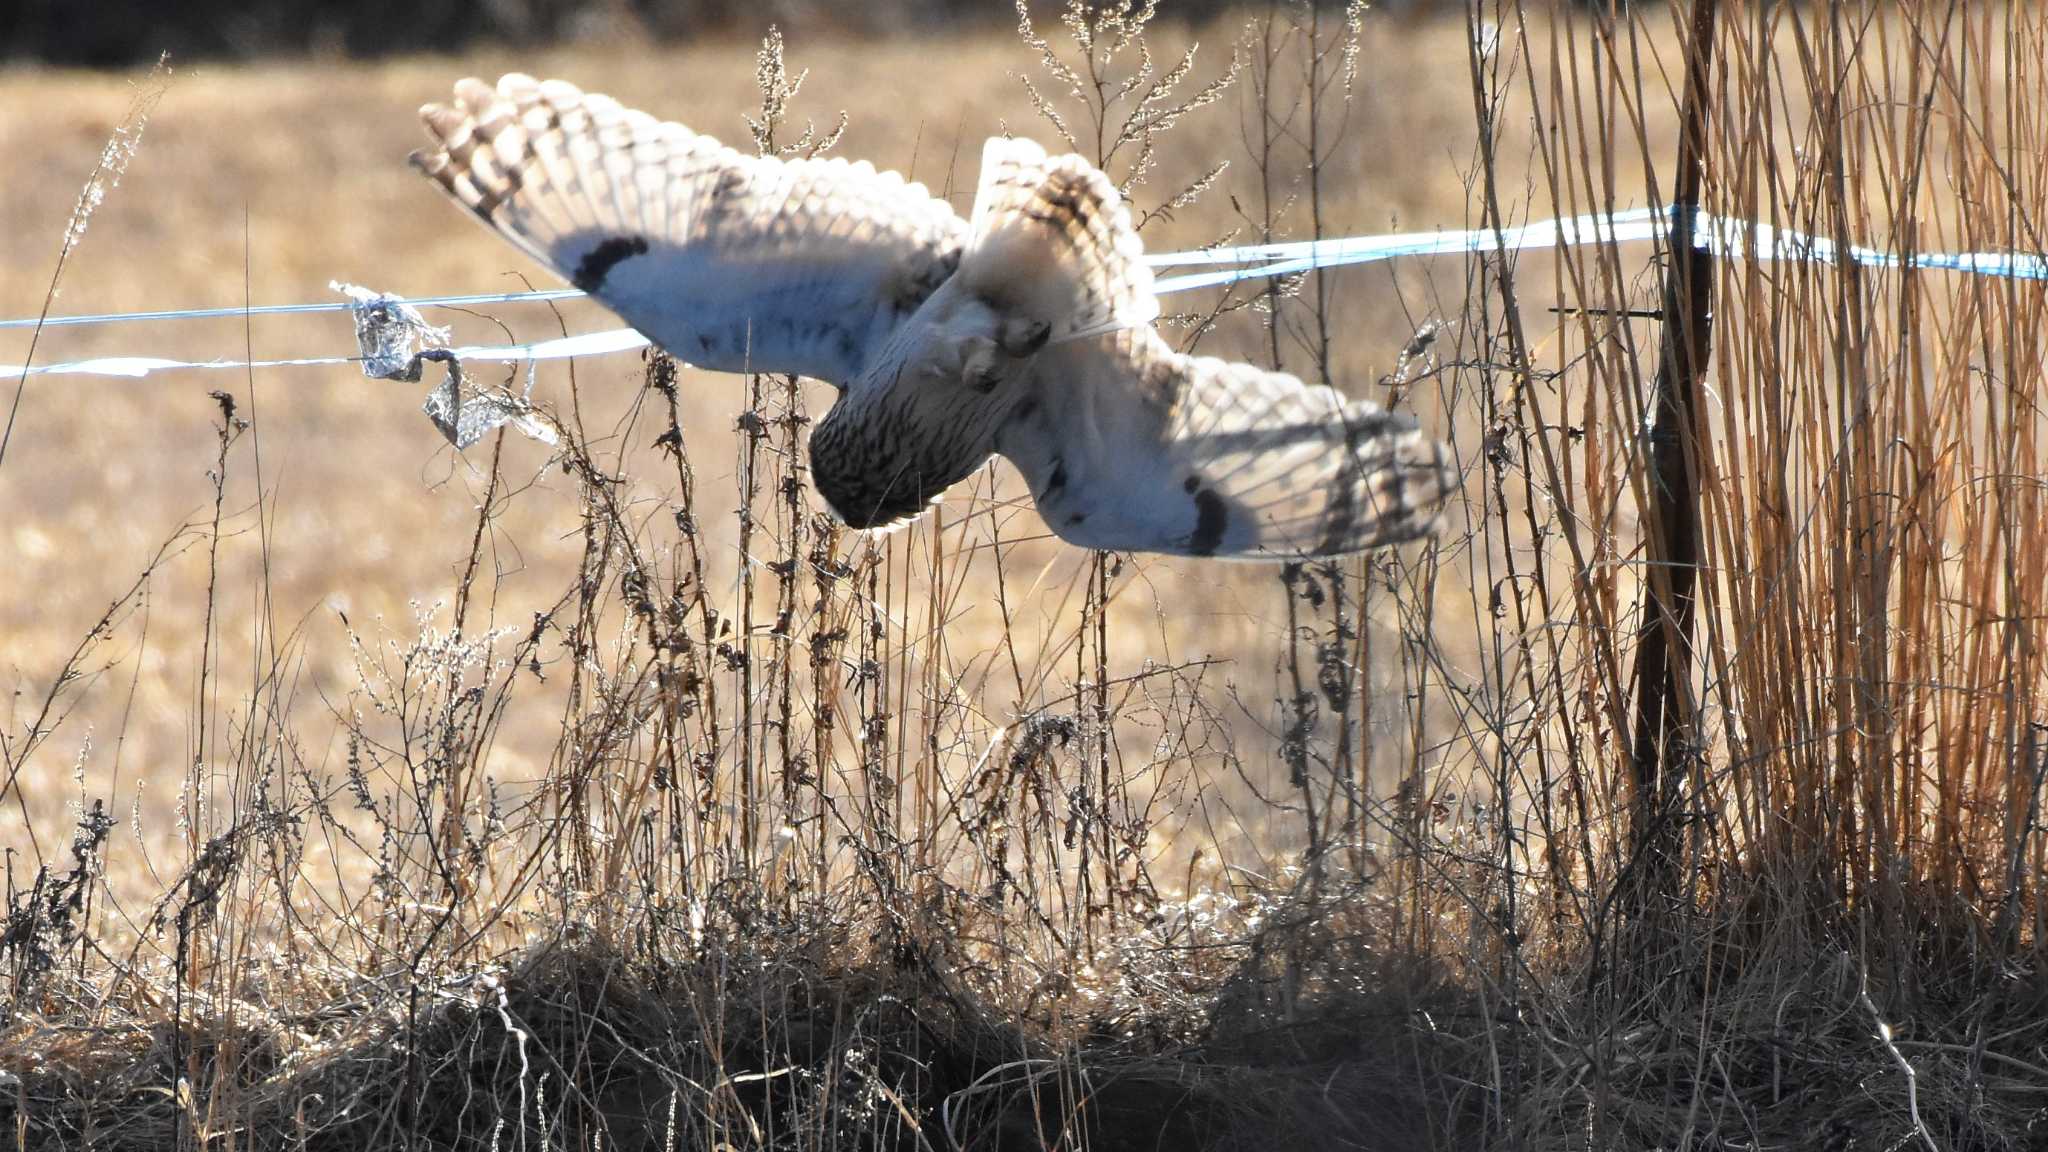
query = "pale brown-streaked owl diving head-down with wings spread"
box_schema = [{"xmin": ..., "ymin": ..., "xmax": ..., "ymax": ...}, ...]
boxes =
[{"xmin": 412, "ymin": 74, "xmax": 1456, "ymax": 558}]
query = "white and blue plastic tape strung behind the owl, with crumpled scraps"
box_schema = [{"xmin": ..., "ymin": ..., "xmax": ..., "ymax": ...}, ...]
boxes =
[{"xmin": 12, "ymin": 209, "xmax": 2048, "ymax": 426}]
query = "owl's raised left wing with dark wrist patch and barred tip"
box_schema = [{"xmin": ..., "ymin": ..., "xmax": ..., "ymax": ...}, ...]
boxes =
[{"xmin": 412, "ymin": 74, "xmax": 967, "ymax": 385}]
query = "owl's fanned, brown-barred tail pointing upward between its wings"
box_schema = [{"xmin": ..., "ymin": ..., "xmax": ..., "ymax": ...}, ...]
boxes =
[{"xmin": 958, "ymin": 137, "xmax": 1159, "ymax": 340}]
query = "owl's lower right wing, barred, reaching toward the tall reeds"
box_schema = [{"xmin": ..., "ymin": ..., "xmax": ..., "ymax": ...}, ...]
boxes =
[{"xmin": 999, "ymin": 328, "xmax": 1458, "ymax": 560}]
